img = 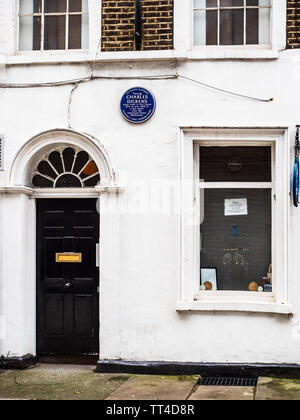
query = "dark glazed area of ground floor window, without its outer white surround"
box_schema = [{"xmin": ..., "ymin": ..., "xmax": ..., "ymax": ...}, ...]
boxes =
[{"xmin": 197, "ymin": 146, "xmax": 272, "ymax": 292}]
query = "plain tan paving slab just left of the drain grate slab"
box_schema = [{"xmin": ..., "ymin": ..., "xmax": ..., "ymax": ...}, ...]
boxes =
[{"xmin": 106, "ymin": 375, "xmax": 199, "ymax": 400}]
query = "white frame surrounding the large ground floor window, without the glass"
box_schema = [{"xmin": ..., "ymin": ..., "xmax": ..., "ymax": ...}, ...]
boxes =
[{"xmin": 177, "ymin": 128, "xmax": 292, "ymax": 314}]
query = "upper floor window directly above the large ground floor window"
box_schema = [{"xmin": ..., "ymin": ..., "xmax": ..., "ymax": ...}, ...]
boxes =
[{"xmin": 193, "ymin": 0, "xmax": 271, "ymax": 46}]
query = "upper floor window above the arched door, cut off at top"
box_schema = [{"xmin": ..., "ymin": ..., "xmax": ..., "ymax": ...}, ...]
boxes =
[{"xmin": 19, "ymin": 0, "xmax": 89, "ymax": 51}]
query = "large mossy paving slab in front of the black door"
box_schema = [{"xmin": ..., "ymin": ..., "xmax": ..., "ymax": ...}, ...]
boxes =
[{"xmin": 0, "ymin": 365, "xmax": 128, "ymax": 400}]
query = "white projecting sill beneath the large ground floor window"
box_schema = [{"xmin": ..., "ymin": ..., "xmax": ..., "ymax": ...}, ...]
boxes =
[{"xmin": 176, "ymin": 300, "xmax": 293, "ymax": 315}]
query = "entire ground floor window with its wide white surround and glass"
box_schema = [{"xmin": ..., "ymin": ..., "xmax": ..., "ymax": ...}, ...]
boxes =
[{"xmin": 177, "ymin": 128, "xmax": 291, "ymax": 313}]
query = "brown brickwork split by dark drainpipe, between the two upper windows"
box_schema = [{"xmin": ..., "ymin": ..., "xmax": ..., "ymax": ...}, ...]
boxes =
[{"xmin": 101, "ymin": 0, "xmax": 173, "ymax": 51}]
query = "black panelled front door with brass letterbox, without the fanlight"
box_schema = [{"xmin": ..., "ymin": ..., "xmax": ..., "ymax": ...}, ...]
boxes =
[{"xmin": 37, "ymin": 199, "xmax": 99, "ymax": 355}]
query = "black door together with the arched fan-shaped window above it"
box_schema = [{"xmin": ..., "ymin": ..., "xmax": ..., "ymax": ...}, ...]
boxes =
[{"xmin": 31, "ymin": 145, "xmax": 100, "ymax": 355}]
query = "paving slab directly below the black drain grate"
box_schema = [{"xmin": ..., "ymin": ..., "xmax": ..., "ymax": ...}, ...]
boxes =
[{"xmin": 189, "ymin": 385, "xmax": 254, "ymax": 401}]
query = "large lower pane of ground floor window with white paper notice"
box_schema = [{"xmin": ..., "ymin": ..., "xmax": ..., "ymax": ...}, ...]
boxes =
[{"xmin": 200, "ymin": 189, "xmax": 272, "ymax": 292}]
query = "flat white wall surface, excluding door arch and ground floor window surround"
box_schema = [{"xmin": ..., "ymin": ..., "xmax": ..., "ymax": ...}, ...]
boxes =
[{"xmin": 0, "ymin": 2, "xmax": 300, "ymax": 363}]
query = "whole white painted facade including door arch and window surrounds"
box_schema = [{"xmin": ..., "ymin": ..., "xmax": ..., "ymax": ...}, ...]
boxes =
[{"xmin": 0, "ymin": 0, "xmax": 300, "ymax": 364}]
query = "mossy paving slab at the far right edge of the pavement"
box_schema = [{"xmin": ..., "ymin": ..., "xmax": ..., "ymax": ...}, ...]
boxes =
[{"xmin": 255, "ymin": 378, "xmax": 300, "ymax": 401}]
